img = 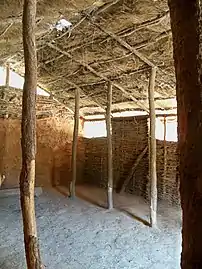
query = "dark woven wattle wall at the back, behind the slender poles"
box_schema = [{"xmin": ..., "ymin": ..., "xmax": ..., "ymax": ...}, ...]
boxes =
[{"xmin": 84, "ymin": 117, "xmax": 179, "ymax": 204}]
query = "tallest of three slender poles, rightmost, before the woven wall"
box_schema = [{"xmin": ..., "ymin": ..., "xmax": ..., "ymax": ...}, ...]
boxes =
[{"xmin": 148, "ymin": 67, "xmax": 157, "ymax": 227}]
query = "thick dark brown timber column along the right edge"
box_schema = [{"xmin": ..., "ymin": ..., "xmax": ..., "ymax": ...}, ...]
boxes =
[{"xmin": 169, "ymin": 0, "xmax": 202, "ymax": 269}]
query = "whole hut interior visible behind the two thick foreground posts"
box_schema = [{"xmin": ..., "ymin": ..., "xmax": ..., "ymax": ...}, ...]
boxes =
[{"xmin": 0, "ymin": 0, "xmax": 199, "ymax": 269}]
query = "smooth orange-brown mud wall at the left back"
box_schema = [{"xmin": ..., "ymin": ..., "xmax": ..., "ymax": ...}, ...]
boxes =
[{"xmin": 0, "ymin": 118, "xmax": 84, "ymax": 188}]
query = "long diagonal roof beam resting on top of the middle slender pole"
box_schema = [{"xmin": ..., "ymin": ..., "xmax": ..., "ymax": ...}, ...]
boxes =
[{"xmin": 47, "ymin": 43, "xmax": 149, "ymax": 112}]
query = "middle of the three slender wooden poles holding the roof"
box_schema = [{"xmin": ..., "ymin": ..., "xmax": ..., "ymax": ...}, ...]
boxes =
[{"xmin": 106, "ymin": 82, "xmax": 113, "ymax": 209}]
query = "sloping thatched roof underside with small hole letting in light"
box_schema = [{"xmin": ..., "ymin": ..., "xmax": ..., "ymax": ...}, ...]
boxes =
[{"xmin": 0, "ymin": 0, "xmax": 176, "ymax": 116}]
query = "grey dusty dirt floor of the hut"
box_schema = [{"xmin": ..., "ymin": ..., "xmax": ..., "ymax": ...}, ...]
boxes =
[{"xmin": 0, "ymin": 187, "xmax": 181, "ymax": 269}]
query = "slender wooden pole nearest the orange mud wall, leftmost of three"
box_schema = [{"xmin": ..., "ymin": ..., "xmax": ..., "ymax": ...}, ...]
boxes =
[{"xmin": 70, "ymin": 88, "xmax": 80, "ymax": 198}]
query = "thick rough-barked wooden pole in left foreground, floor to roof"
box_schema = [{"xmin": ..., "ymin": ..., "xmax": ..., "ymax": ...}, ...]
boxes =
[{"xmin": 20, "ymin": 0, "xmax": 42, "ymax": 269}]
